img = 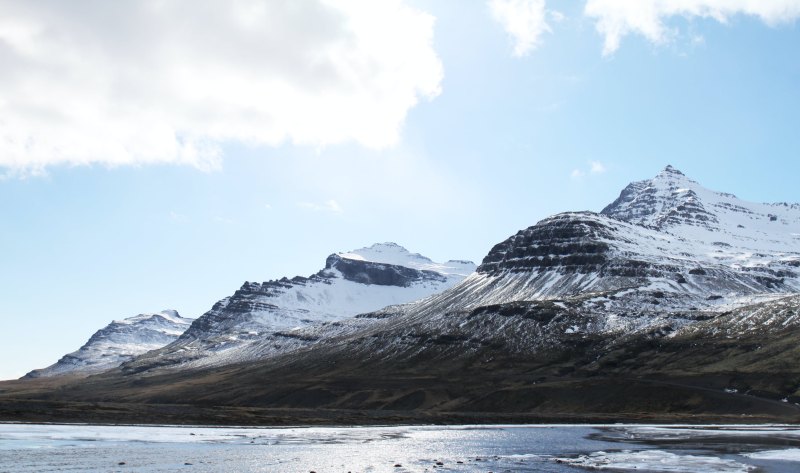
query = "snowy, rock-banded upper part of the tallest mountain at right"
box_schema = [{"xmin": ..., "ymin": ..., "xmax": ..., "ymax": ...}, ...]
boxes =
[{"xmin": 354, "ymin": 166, "xmax": 800, "ymax": 322}]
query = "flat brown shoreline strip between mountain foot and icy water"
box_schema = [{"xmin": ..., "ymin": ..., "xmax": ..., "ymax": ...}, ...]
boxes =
[{"xmin": 0, "ymin": 399, "xmax": 800, "ymax": 428}]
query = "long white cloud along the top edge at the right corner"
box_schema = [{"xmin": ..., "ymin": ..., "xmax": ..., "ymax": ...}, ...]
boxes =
[{"xmin": 584, "ymin": 0, "xmax": 800, "ymax": 55}]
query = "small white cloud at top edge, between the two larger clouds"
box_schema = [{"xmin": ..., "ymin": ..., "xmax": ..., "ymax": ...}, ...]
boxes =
[{"xmin": 489, "ymin": 0, "xmax": 552, "ymax": 57}]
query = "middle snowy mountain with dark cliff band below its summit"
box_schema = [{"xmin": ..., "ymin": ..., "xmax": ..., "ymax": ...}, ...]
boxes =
[{"xmin": 119, "ymin": 243, "xmax": 476, "ymax": 371}]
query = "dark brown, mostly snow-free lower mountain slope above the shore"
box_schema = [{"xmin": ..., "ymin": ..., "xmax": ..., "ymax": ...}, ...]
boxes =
[{"xmin": 20, "ymin": 296, "xmax": 800, "ymax": 423}]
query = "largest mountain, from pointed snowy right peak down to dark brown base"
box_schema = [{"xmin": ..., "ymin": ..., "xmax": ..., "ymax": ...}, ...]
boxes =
[{"xmin": 6, "ymin": 167, "xmax": 800, "ymax": 422}]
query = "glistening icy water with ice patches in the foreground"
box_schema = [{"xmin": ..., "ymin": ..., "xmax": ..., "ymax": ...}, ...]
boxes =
[{"xmin": 0, "ymin": 424, "xmax": 800, "ymax": 473}]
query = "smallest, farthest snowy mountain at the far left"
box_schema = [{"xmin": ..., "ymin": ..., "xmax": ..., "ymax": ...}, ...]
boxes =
[{"xmin": 25, "ymin": 310, "xmax": 193, "ymax": 378}]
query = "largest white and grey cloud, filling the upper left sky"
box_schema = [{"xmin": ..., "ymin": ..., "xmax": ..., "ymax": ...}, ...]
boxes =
[{"xmin": 0, "ymin": 0, "xmax": 443, "ymax": 174}]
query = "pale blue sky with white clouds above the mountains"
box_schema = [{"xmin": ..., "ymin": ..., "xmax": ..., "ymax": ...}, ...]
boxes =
[{"xmin": 0, "ymin": 0, "xmax": 800, "ymax": 379}]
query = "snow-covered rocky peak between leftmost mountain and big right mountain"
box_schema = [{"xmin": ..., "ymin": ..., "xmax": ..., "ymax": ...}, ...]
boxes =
[{"xmin": 168, "ymin": 243, "xmax": 475, "ymax": 350}]
